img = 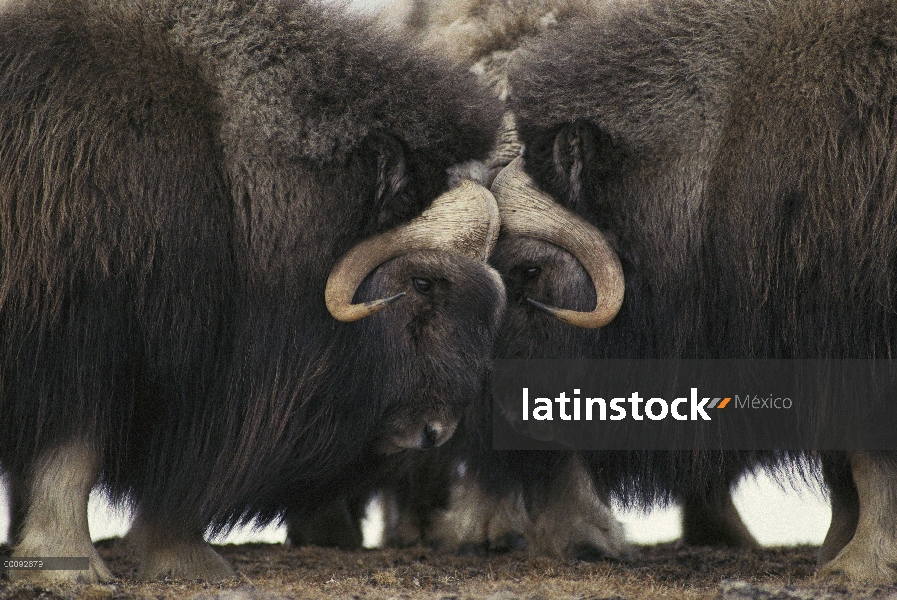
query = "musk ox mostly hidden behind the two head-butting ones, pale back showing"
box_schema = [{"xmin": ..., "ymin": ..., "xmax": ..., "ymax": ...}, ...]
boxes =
[{"xmin": 286, "ymin": 0, "xmax": 625, "ymax": 556}]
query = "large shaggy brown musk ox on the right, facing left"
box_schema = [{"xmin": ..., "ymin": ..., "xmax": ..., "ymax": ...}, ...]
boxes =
[{"xmin": 481, "ymin": 0, "xmax": 897, "ymax": 582}]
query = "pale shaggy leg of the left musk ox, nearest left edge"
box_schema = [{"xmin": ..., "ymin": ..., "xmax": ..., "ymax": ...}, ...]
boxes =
[{"xmin": 10, "ymin": 440, "xmax": 112, "ymax": 583}]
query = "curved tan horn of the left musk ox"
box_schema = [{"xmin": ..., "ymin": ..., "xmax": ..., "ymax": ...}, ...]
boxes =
[{"xmin": 324, "ymin": 181, "xmax": 500, "ymax": 322}]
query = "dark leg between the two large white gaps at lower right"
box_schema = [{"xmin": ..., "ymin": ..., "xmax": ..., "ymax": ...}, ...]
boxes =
[{"xmin": 682, "ymin": 488, "xmax": 760, "ymax": 549}]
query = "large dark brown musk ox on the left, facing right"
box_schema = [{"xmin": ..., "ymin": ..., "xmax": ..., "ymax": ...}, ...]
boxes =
[{"xmin": 0, "ymin": 0, "xmax": 504, "ymax": 580}]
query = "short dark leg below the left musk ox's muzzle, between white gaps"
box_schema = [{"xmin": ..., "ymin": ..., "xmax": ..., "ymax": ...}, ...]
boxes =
[{"xmin": 284, "ymin": 497, "xmax": 364, "ymax": 550}]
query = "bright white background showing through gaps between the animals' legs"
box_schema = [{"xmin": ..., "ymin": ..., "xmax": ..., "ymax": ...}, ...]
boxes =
[{"xmin": 0, "ymin": 0, "xmax": 831, "ymax": 545}]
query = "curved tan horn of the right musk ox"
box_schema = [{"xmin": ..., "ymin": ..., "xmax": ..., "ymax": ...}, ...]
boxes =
[{"xmin": 492, "ymin": 157, "xmax": 624, "ymax": 327}]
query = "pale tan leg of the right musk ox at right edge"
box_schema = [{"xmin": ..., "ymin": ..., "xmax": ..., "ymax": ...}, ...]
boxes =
[{"xmin": 820, "ymin": 452, "xmax": 897, "ymax": 584}]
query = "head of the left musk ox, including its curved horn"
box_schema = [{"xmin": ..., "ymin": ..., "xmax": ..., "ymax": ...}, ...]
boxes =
[{"xmin": 325, "ymin": 169, "xmax": 504, "ymax": 452}]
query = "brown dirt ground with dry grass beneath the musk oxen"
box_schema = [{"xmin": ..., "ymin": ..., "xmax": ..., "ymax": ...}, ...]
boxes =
[{"xmin": 0, "ymin": 540, "xmax": 897, "ymax": 600}]
